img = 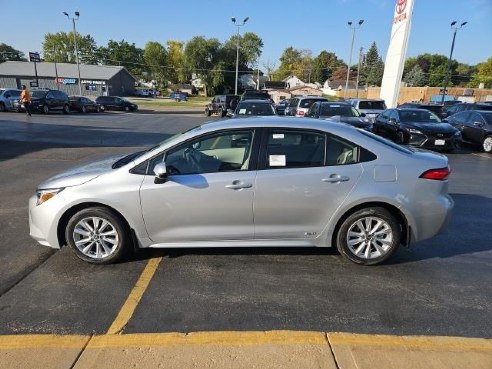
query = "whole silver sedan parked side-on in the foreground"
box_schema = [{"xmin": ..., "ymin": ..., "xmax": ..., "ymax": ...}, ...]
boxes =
[{"xmin": 29, "ymin": 117, "xmax": 454, "ymax": 265}]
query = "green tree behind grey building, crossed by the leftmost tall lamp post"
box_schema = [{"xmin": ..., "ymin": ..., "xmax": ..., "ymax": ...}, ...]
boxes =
[{"xmin": 43, "ymin": 32, "xmax": 99, "ymax": 64}]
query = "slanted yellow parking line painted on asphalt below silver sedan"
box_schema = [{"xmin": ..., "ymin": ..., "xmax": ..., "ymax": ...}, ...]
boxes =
[{"xmin": 107, "ymin": 258, "xmax": 162, "ymax": 334}]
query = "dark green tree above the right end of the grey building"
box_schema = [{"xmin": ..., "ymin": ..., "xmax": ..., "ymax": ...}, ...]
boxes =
[{"xmin": 99, "ymin": 40, "xmax": 144, "ymax": 78}]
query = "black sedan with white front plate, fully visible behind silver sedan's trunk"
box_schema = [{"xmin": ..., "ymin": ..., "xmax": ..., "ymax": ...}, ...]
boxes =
[{"xmin": 374, "ymin": 108, "xmax": 461, "ymax": 152}]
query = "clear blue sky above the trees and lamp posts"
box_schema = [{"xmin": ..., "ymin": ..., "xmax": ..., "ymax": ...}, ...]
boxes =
[{"xmin": 0, "ymin": 0, "xmax": 492, "ymax": 70}]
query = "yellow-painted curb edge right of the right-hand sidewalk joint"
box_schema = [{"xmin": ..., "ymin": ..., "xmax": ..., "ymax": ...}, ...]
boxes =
[{"xmin": 327, "ymin": 333, "xmax": 492, "ymax": 352}]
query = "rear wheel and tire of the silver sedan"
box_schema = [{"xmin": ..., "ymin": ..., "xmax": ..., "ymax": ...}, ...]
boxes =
[{"xmin": 337, "ymin": 207, "xmax": 401, "ymax": 265}]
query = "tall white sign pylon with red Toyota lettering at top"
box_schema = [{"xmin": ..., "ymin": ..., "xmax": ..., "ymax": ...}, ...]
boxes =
[{"xmin": 380, "ymin": 0, "xmax": 415, "ymax": 108}]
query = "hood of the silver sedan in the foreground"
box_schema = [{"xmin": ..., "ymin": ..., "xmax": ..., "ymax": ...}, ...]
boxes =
[{"xmin": 38, "ymin": 155, "xmax": 122, "ymax": 189}]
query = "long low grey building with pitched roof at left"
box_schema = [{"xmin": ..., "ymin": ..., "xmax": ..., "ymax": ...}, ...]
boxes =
[{"xmin": 0, "ymin": 61, "xmax": 136, "ymax": 96}]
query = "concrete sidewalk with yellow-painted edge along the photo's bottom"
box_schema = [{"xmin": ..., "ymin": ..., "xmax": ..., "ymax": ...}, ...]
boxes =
[{"xmin": 0, "ymin": 331, "xmax": 492, "ymax": 369}]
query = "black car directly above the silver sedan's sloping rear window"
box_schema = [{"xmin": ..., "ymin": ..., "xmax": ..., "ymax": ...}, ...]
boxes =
[{"xmin": 305, "ymin": 101, "xmax": 372, "ymax": 131}]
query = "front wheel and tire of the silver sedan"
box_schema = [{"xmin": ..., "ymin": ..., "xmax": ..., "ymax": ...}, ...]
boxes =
[{"xmin": 65, "ymin": 207, "xmax": 131, "ymax": 264}]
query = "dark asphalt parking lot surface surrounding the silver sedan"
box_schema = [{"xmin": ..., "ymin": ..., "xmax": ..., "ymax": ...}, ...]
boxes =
[{"xmin": 0, "ymin": 113, "xmax": 492, "ymax": 338}]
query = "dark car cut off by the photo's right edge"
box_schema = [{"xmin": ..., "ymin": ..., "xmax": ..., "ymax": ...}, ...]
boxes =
[{"xmin": 446, "ymin": 110, "xmax": 492, "ymax": 153}]
